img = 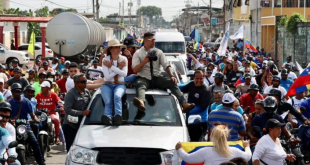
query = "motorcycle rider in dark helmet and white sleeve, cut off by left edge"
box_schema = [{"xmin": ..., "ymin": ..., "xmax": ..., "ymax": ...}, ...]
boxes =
[{"xmin": 0, "ymin": 102, "xmax": 20, "ymax": 165}]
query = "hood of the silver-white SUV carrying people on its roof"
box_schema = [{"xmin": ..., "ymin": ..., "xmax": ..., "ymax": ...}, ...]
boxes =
[{"xmin": 75, "ymin": 125, "xmax": 188, "ymax": 150}]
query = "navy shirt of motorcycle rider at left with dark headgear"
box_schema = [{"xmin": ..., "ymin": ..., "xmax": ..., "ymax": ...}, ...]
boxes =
[{"xmin": 8, "ymin": 98, "xmax": 34, "ymax": 120}]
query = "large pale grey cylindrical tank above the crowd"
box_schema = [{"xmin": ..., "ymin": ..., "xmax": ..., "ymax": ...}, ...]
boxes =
[{"xmin": 46, "ymin": 12, "xmax": 113, "ymax": 61}]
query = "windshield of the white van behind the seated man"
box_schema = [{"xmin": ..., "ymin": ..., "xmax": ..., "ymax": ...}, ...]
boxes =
[{"xmin": 155, "ymin": 42, "xmax": 185, "ymax": 54}]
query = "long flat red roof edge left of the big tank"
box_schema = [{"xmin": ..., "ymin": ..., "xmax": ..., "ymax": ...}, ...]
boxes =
[{"xmin": 0, "ymin": 17, "xmax": 53, "ymax": 23}]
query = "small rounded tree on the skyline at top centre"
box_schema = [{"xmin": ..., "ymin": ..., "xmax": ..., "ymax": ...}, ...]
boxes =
[{"xmin": 137, "ymin": 6, "xmax": 162, "ymax": 24}]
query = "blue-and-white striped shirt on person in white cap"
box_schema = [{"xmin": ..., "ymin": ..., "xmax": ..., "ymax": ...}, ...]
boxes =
[{"xmin": 208, "ymin": 107, "xmax": 245, "ymax": 141}]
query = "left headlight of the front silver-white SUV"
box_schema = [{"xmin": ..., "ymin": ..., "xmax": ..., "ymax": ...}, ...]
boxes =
[{"xmin": 70, "ymin": 146, "xmax": 98, "ymax": 164}]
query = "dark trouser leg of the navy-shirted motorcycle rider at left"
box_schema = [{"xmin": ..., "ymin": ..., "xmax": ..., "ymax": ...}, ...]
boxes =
[{"xmin": 28, "ymin": 132, "xmax": 44, "ymax": 164}]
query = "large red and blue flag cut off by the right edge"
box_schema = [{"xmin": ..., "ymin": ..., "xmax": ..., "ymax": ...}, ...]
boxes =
[{"xmin": 286, "ymin": 66, "xmax": 310, "ymax": 96}]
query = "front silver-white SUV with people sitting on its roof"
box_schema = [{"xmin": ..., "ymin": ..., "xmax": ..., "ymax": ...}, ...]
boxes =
[{"xmin": 66, "ymin": 89, "xmax": 190, "ymax": 165}]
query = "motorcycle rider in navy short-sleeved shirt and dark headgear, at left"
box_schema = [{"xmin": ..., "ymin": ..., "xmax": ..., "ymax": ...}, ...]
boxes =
[{"xmin": 8, "ymin": 83, "xmax": 45, "ymax": 165}]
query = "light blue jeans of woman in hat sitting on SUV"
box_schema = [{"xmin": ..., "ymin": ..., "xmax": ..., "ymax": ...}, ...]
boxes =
[{"xmin": 101, "ymin": 84, "xmax": 126, "ymax": 119}]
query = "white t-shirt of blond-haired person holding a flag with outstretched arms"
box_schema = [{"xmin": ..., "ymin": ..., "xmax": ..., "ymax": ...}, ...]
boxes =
[{"xmin": 177, "ymin": 147, "xmax": 252, "ymax": 165}]
